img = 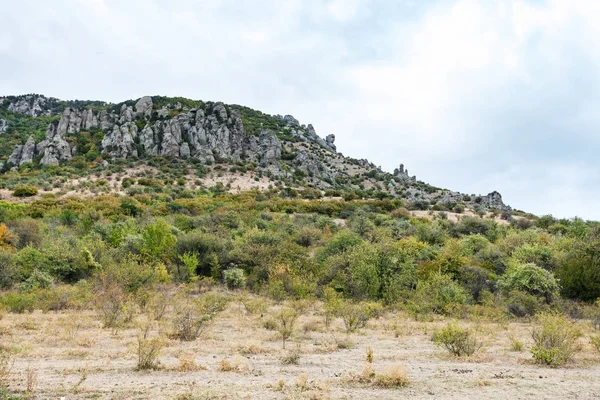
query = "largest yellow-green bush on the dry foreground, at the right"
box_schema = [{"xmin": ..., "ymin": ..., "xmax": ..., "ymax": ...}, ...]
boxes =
[{"xmin": 531, "ymin": 314, "xmax": 581, "ymax": 367}]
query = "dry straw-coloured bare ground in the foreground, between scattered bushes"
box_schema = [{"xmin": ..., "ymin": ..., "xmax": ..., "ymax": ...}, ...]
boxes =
[{"xmin": 0, "ymin": 294, "xmax": 600, "ymax": 400}]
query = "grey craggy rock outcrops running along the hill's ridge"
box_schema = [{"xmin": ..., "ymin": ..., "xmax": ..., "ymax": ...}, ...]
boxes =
[{"xmin": 0, "ymin": 95, "xmax": 510, "ymax": 210}]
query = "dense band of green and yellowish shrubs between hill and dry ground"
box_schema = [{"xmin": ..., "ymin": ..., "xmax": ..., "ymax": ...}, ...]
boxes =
[{"xmin": 0, "ymin": 186, "xmax": 600, "ymax": 330}]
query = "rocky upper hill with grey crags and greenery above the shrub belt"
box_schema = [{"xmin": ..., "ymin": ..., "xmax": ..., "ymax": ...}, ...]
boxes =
[{"xmin": 0, "ymin": 94, "xmax": 510, "ymax": 211}]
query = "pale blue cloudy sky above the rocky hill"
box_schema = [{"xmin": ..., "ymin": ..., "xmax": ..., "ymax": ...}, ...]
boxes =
[{"xmin": 0, "ymin": 0, "xmax": 600, "ymax": 220}]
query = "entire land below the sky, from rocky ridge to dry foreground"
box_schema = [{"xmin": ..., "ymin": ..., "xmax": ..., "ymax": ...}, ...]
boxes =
[{"xmin": 0, "ymin": 95, "xmax": 600, "ymax": 400}]
